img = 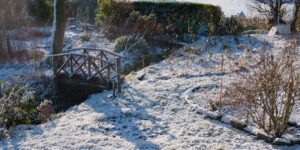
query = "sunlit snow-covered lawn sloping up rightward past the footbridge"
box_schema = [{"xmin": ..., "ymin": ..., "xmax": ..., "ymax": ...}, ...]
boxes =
[{"xmin": 0, "ymin": 34, "xmax": 300, "ymax": 150}]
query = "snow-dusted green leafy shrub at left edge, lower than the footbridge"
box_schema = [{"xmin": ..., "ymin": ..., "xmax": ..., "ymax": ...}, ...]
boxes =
[{"xmin": 0, "ymin": 82, "xmax": 37, "ymax": 128}]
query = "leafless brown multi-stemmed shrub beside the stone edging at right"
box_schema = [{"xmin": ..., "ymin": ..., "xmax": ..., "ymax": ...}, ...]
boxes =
[{"xmin": 227, "ymin": 42, "xmax": 300, "ymax": 137}]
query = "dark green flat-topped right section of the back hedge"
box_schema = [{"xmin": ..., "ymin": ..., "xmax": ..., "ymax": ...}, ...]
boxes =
[{"xmin": 132, "ymin": 2, "xmax": 223, "ymax": 35}]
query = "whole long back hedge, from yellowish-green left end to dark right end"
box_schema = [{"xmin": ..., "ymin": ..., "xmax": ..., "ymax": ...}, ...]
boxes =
[{"xmin": 96, "ymin": 0, "xmax": 223, "ymax": 39}]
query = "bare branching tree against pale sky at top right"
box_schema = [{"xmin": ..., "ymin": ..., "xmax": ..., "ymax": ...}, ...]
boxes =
[{"xmin": 253, "ymin": 0, "xmax": 290, "ymax": 25}]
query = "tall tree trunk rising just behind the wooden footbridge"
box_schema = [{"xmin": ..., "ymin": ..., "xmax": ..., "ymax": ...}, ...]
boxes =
[{"xmin": 51, "ymin": 0, "xmax": 67, "ymax": 73}]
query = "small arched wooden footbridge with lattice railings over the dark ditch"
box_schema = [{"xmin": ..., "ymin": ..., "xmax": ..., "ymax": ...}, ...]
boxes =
[{"xmin": 48, "ymin": 48, "xmax": 124, "ymax": 92}]
